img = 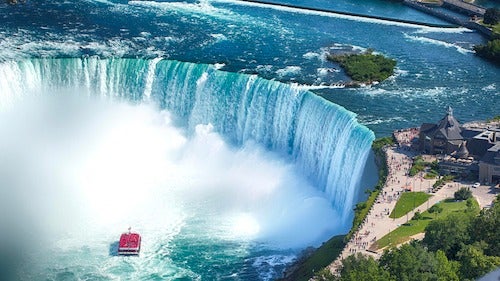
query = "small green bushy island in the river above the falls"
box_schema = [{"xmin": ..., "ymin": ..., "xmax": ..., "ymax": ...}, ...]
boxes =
[{"xmin": 327, "ymin": 50, "xmax": 396, "ymax": 84}]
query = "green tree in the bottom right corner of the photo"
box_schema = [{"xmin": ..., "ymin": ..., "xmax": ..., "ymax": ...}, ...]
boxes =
[{"xmin": 457, "ymin": 244, "xmax": 500, "ymax": 280}]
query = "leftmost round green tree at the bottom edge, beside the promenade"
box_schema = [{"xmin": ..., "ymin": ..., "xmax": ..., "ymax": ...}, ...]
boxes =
[{"xmin": 339, "ymin": 254, "xmax": 395, "ymax": 281}]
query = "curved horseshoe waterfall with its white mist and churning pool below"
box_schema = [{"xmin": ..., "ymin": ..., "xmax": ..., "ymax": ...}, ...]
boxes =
[{"xmin": 0, "ymin": 57, "xmax": 374, "ymax": 280}]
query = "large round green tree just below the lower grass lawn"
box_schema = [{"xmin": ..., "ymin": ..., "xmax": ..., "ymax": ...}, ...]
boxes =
[{"xmin": 423, "ymin": 213, "xmax": 472, "ymax": 259}]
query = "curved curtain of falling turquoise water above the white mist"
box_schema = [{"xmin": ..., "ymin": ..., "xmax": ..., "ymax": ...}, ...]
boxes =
[{"xmin": 0, "ymin": 58, "xmax": 374, "ymax": 225}]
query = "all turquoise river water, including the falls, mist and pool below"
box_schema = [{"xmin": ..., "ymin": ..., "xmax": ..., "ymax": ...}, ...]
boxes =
[{"xmin": 0, "ymin": 0, "xmax": 500, "ymax": 280}]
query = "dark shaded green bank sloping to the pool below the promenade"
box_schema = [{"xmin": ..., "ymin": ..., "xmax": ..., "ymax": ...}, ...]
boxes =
[{"xmin": 287, "ymin": 235, "xmax": 345, "ymax": 280}]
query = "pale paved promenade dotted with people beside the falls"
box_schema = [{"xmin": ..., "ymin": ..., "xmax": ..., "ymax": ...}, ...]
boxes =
[{"xmin": 330, "ymin": 144, "xmax": 496, "ymax": 274}]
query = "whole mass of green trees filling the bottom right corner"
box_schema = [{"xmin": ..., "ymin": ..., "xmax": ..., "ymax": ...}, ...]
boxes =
[{"xmin": 328, "ymin": 199, "xmax": 500, "ymax": 281}]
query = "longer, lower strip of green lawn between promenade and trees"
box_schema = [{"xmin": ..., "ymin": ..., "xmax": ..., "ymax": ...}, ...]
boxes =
[{"xmin": 376, "ymin": 199, "xmax": 479, "ymax": 249}]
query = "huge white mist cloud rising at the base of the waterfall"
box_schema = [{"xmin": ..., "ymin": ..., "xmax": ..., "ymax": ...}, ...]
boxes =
[{"xmin": 0, "ymin": 89, "xmax": 337, "ymax": 252}]
